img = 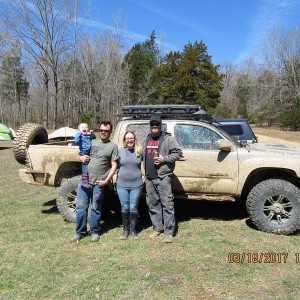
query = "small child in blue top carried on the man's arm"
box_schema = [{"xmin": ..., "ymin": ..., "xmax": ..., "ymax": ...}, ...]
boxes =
[{"xmin": 75, "ymin": 123, "xmax": 96, "ymax": 188}]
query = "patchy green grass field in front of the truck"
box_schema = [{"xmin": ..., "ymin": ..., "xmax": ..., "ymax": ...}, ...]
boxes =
[{"xmin": 0, "ymin": 145, "xmax": 300, "ymax": 300}]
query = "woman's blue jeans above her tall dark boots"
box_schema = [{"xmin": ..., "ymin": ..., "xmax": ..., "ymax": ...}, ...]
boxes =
[{"xmin": 117, "ymin": 187, "xmax": 143, "ymax": 213}]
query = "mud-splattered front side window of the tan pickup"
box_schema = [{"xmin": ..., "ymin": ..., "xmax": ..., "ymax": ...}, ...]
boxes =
[{"xmin": 175, "ymin": 124, "xmax": 222, "ymax": 150}]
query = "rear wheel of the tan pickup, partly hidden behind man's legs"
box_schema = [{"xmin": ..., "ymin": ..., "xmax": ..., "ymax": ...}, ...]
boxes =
[{"xmin": 56, "ymin": 176, "xmax": 81, "ymax": 223}]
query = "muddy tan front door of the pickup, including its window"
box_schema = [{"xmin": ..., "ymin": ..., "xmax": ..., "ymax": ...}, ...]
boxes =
[{"xmin": 172, "ymin": 124, "xmax": 238, "ymax": 194}]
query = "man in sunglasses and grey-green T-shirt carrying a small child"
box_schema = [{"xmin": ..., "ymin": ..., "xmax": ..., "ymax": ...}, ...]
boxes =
[{"xmin": 70, "ymin": 121, "xmax": 118, "ymax": 242}]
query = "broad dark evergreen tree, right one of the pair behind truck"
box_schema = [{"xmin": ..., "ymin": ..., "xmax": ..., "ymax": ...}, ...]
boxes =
[{"xmin": 154, "ymin": 41, "xmax": 223, "ymax": 112}]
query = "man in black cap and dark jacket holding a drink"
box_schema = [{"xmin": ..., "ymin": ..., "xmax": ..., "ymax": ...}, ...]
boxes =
[{"xmin": 143, "ymin": 115, "xmax": 182, "ymax": 243}]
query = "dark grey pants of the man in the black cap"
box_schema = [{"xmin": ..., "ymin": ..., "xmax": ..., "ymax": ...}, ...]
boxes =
[{"xmin": 146, "ymin": 176, "xmax": 175, "ymax": 235}]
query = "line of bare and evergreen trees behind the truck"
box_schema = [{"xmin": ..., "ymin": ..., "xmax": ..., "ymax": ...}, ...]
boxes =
[{"xmin": 0, "ymin": 0, "xmax": 300, "ymax": 130}]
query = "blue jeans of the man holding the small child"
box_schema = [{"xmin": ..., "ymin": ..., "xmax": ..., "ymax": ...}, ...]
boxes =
[{"xmin": 76, "ymin": 183, "xmax": 104, "ymax": 236}]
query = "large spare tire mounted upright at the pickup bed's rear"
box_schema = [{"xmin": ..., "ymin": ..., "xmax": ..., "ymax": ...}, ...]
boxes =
[{"xmin": 13, "ymin": 123, "xmax": 48, "ymax": 165}]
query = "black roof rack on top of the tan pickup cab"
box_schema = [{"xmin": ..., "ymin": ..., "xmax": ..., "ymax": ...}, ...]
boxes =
[{"xmin": 122, "ymin": 104, "xmax": 211, "ymax": 121}]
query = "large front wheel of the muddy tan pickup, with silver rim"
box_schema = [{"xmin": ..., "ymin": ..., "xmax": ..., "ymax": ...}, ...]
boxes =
[{"xmin": 246, "ymin": 179, "xmax": 300, "ymax": 234}]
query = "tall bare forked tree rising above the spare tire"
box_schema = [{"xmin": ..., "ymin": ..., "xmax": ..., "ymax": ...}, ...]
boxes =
[{"xmin": 2, "ymin": 0, "xmax": 77, "ymax": 128}]
